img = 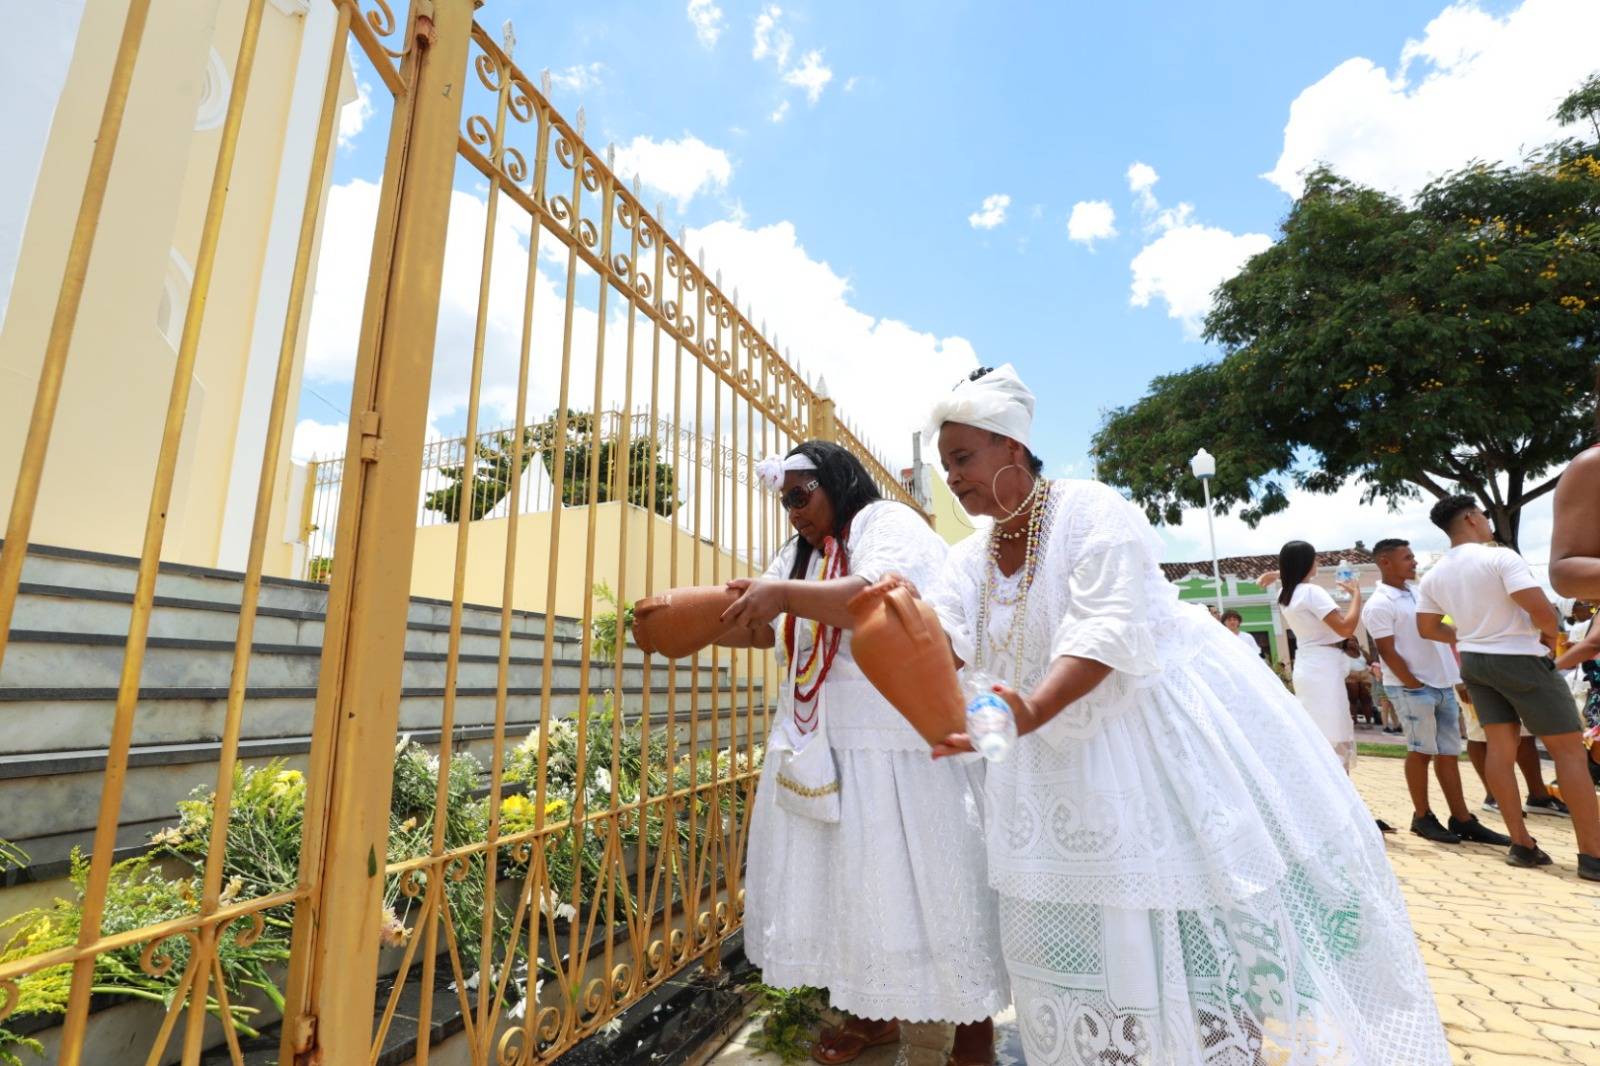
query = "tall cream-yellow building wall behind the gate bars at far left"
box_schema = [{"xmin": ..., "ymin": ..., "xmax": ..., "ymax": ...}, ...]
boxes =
[{"xmin": 0, "ymin": 0, "xmax": 324, "ymax": 570}]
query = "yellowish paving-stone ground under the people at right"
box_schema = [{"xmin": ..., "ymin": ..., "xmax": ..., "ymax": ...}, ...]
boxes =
[{"xmin": 714, "ymin": 757, "xmax": 1600, "ymax": 1066}]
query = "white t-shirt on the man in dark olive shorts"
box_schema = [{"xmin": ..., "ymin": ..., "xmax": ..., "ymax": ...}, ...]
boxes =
[{"xmin": 1416, "ymin": 544, "xmax": 1547, "ymax": 655}]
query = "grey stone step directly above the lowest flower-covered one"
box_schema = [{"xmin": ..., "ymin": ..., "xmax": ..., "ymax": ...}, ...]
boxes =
[{"xmin": 0, "ymin": 667, "xmax": 762, "ymax": 752}]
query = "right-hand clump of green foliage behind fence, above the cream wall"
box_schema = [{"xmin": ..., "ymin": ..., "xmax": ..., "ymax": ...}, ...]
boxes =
[{"xmin": 530, "ymin": 410, "xmax": 678, "ymax": 517}]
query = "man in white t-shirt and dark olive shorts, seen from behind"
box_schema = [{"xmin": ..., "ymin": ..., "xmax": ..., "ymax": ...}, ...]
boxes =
[{"xmin": 1416, "ymin": 496, "xmax": 1600, "ymax": 880}]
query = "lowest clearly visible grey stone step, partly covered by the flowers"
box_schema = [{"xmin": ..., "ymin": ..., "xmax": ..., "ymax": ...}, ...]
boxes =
[{"xmin": 0, "ymin": 691, "xmax": 762, "ymax": 850}]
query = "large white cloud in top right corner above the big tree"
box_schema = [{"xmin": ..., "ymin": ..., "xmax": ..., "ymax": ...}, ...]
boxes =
[{"xmin": 1264, "ymin": 0, "xmax": 1600, "ymax": 197}]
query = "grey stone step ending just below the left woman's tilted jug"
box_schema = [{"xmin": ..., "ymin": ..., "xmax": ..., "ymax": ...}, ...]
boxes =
[{"xmin": 0, "ymin": 629, "xmax": 728, "ymax": 694}]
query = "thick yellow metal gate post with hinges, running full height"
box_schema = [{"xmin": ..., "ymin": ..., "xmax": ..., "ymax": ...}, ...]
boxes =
[{"xmin": 280, "ymin": 0, "xmax": 475, "ymax": 1066}]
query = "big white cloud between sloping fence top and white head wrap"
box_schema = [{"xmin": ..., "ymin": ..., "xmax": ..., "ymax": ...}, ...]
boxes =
[{"xmin": 688, "ymin": 222, "xmax": 978, "ymax": 463}]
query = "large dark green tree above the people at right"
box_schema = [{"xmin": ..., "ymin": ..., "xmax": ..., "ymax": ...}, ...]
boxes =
[{"xmin": 1093, "ymin": 112, "xmax": 1600, "ymax": 544}]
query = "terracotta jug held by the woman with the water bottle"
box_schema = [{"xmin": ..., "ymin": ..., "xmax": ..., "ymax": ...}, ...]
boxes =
[{"xmin": 846, "ymin": 581, "xmax": 966, "ymax": 747}]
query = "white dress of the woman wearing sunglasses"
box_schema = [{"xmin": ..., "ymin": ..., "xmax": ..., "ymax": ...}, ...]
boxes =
[{"xmin": 744, "ymin": 503, "xmax": 1011, "ymax": 1023}]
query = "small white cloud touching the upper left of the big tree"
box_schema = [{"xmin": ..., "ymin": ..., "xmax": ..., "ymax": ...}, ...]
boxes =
[{"xmin": 1130, "ymin": 222, "xmax": 1272, "ymax": 338}]
